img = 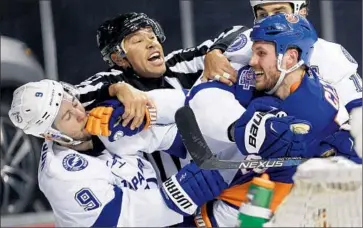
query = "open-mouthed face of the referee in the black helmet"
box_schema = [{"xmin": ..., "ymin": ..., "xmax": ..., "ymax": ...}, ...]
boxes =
[{"xmin": 124, "ymin": 27, "xmax": 166, "ymax": 78}]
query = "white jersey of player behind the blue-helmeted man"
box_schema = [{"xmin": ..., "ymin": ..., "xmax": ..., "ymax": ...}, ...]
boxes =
[{"xmin": 224, "ymin": 26, "xmax": 363, "ymax": 112}]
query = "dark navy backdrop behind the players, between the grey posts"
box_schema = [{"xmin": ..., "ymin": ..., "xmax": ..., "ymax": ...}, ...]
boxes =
[{"xmin": 0, "ymin": 0, "xmax": 362, "ymax": 83}]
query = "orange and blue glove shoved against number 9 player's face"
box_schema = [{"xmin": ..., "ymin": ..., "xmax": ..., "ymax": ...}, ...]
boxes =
[{"xmin": 86, "ymin": 99, "xmax": 156, "ymax": 142}]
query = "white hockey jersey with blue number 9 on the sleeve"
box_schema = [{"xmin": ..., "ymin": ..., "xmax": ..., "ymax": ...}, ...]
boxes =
[{"xmin": 38, "ymin": 90, "xmax": 188, "ymax": 227}]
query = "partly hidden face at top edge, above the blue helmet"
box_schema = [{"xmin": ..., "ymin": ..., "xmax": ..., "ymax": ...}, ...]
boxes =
[{"xmin": 256, "ymin": 2, "xmax": 293, "ymax": 20}]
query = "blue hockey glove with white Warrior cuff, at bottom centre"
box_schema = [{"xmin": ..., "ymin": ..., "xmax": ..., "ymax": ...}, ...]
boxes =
[{"xmin": 160, "ymin": 163, "xmax": 228, "ymax": 216}]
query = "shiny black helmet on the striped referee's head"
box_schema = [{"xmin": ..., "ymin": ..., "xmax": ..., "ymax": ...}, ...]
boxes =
[{"xmin": 97, "ymin": 12, "xmax": 166, "ymax": 66}]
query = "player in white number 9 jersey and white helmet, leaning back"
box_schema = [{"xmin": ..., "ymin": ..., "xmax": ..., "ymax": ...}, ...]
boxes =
[{"xmin": 9, "ymin": 80, "xmax": 227, "ymax": 227}]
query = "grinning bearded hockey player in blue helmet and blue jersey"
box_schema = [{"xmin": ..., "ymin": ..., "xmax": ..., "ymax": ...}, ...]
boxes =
[{"xmin": 187, "ymin": 14, "xmax": 361, "ymax": 227}]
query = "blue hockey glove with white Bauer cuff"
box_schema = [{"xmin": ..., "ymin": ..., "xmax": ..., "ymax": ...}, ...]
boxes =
[{"xmin": 234, "ymin": 99, "xmax": 311, "ymax": 159}]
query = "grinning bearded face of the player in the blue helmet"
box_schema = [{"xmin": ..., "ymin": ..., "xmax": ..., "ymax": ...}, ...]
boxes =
[{"xmin": 250, "ymin": 41, "xmax": 280, "ymax": 91}]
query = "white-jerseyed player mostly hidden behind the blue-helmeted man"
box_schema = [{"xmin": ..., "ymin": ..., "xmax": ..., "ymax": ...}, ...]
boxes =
[{"xmin": 209, "ymin": 0, "xmax": 362, "ymax": 116}]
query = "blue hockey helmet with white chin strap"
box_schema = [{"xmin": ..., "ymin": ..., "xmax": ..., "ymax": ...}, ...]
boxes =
[{"xmin": 250, "ymin": 13, "xmax": 318, "ymax": 94}]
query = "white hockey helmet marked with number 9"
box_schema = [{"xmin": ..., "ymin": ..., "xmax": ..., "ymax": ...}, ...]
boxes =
[{"xmin": 9, "ymin": 79, "xmax": 82, "ymax": 144}]
